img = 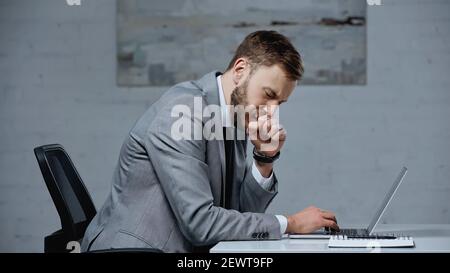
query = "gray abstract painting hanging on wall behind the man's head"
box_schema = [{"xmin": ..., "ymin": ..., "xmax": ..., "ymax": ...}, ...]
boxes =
[{"xmin": 117, "ymin": 0, "xmax": 367, "ymax": 86}]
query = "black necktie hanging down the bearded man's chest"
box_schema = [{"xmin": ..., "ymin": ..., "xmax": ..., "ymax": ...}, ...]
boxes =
[{"xmin": 222, "ymin": 127, "xmax": 235, "ymax": 209}]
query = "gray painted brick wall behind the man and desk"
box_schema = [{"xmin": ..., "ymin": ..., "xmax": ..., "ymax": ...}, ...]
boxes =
[{"xmin": 0, "ymin": 0, "xmax": 450, "ymax": 252}]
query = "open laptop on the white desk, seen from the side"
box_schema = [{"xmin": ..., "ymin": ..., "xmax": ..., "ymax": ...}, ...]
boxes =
[{"xmin": 289, "ymin": 167, "xmax": 408, "ymax": 239}]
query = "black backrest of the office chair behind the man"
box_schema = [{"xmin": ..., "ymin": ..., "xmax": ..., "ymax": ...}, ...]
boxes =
[{"xmin": 34, "ymin": 144, "xmax": 96, "ymax": 240}]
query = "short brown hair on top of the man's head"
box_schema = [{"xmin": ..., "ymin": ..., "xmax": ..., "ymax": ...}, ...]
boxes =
[{"xmin": 227, "ymin": 30, "xmax": 304, "ymax": 80}]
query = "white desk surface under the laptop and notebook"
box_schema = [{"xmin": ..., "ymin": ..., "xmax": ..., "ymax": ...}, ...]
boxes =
[{"xmin": 210, "ymin": 224, "xmax": 450, "ymax": 253}]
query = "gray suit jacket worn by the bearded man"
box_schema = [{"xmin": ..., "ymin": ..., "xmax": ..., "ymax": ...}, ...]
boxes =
[{"xmin": 82, "ymin": 71, "xmax": 281, "ymax": 252}]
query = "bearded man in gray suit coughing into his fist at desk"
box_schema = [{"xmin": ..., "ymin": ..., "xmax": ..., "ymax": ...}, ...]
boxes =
[{"xmin": 82, "ymin": 31, "xmax": 339, "ymax": 252}]
